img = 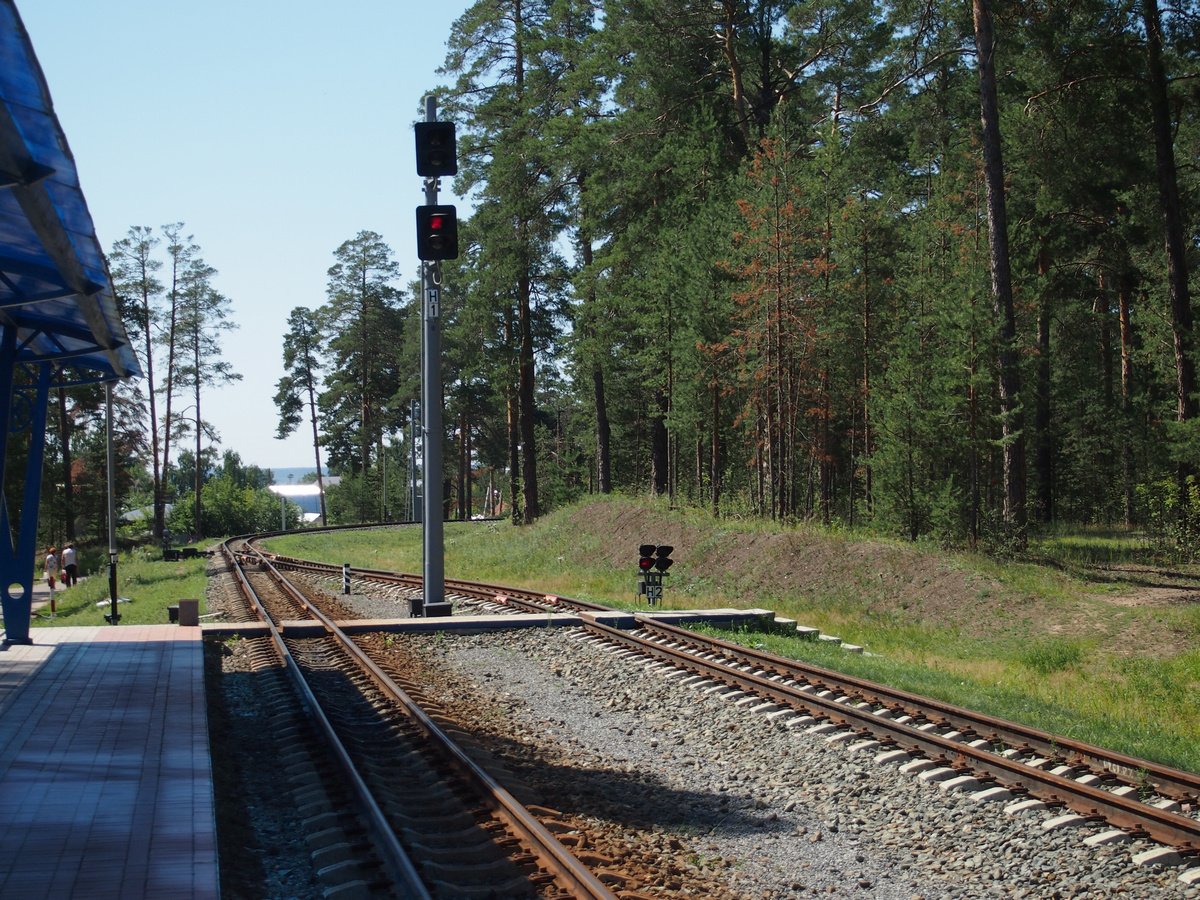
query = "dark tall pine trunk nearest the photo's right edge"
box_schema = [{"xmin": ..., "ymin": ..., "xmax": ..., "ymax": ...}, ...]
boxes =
[{"xmin": 1141, "ymin": 0, "xmax": 1196, "ymax": 509}]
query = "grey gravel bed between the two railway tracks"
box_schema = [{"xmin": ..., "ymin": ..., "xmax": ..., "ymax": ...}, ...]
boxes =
[{"xmin": 369, "ymin": 629, "xmax": 1200, "ymax": 898}]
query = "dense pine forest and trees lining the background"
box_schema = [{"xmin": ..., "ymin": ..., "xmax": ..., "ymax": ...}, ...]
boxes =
[{"xmin": 23, "ymin": 0, "xmax": 1200, "ymax": 556}]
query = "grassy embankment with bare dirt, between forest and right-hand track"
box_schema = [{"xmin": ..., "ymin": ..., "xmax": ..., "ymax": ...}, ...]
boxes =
[{"xmin": 271, "ymin": 499, "xmax": 1200, "ymax": 772}]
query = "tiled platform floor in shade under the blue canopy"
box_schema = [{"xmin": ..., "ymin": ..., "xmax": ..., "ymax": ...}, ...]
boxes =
[{"xmin": 0, "ymin": 624, "xmax": 220, "ymax": 900}]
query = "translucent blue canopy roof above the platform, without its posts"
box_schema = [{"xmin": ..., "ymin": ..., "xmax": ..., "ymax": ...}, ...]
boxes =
[{"xmin": 0, "ymin": 0, "xmax": 142, "ymax": 380}]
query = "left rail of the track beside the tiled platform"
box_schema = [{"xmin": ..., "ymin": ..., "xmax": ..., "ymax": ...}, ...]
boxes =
[{"xmin": 221, "ymin": 541, "xmax": 432, "ymax": 900}]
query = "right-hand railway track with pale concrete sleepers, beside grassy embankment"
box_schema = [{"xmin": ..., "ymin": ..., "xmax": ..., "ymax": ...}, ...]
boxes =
[{"xmin": 248, "ymin": 557, "xmax": 1200, "ymax": 858}]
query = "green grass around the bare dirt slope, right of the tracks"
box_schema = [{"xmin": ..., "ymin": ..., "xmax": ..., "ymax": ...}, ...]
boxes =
[{"xmin": 270, "ymin": 500, "xmax": 1200, "ymax": 772}]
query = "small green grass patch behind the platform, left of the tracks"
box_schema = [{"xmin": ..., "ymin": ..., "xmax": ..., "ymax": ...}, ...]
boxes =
[{"xmin": 32, "ymin": 550, "xmax": 209, "ymax": 628}]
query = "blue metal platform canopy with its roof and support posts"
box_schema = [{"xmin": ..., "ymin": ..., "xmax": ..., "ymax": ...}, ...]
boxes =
[{"xmin": 0, "ymin": 0, "xmax": 142, "ymax": 643}]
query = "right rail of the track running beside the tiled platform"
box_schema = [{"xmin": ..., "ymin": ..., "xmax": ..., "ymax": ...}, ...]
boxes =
[{"xmin": 243, "ymin": 542, "xmax": 616, "ymax": 900}]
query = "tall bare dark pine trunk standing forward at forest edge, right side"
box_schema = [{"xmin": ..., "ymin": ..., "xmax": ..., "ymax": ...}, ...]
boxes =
[{"xmin": 972, "ymin": 0, "xmax": 1026, "ymax": 546}]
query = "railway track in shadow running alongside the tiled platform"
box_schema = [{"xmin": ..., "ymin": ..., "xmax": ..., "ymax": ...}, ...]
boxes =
[{"xmin": 216, "ymin": 546, "xmax": 616, "ymax": 898}]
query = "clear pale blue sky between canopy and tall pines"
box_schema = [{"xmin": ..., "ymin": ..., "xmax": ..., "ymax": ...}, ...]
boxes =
[{"xmin": 17, "ymin": 0, "xmax": 469, "ymax": 468}]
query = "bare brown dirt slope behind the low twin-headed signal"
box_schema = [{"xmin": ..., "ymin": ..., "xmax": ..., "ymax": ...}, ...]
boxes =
[{"xmin": 559, "ymin": 499, "xmax": 1200, "ymax": 652}]
